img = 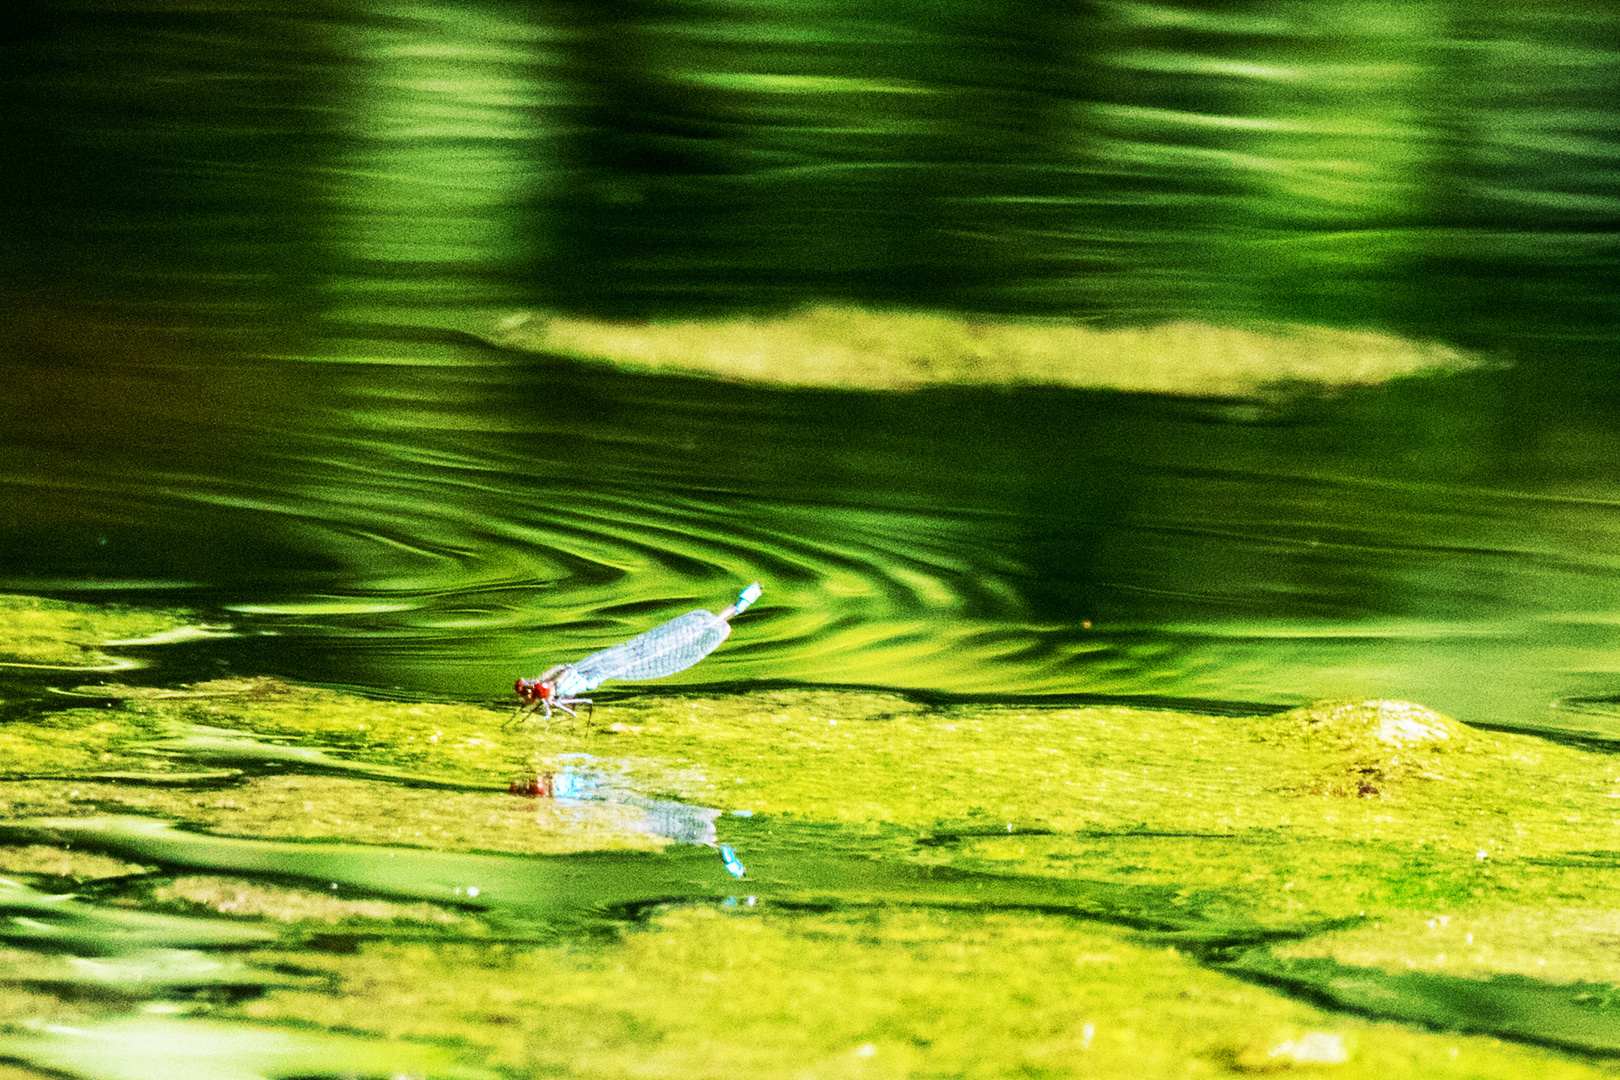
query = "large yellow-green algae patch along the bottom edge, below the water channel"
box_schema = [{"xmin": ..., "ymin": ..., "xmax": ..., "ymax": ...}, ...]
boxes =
[{"xmin": 232, "ymin": 904, "xmax": 1604, "ymax": 1080}]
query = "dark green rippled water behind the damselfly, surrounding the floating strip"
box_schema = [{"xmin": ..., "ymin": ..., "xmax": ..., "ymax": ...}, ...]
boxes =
[{"xmin": 0, "ymin": 2, "xmax": 1620, "ymax": 730}]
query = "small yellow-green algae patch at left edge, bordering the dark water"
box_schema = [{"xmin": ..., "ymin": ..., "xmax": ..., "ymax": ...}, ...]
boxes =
[{"xmin": 0, "ymin": 596, "xmax": 209, "ymax": 670}]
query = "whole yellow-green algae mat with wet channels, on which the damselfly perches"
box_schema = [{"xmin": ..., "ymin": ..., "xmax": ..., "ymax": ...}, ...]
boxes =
[{"xmin": 0, "ymin": 601, "xmax": 1620, "ymax": 1080}]
